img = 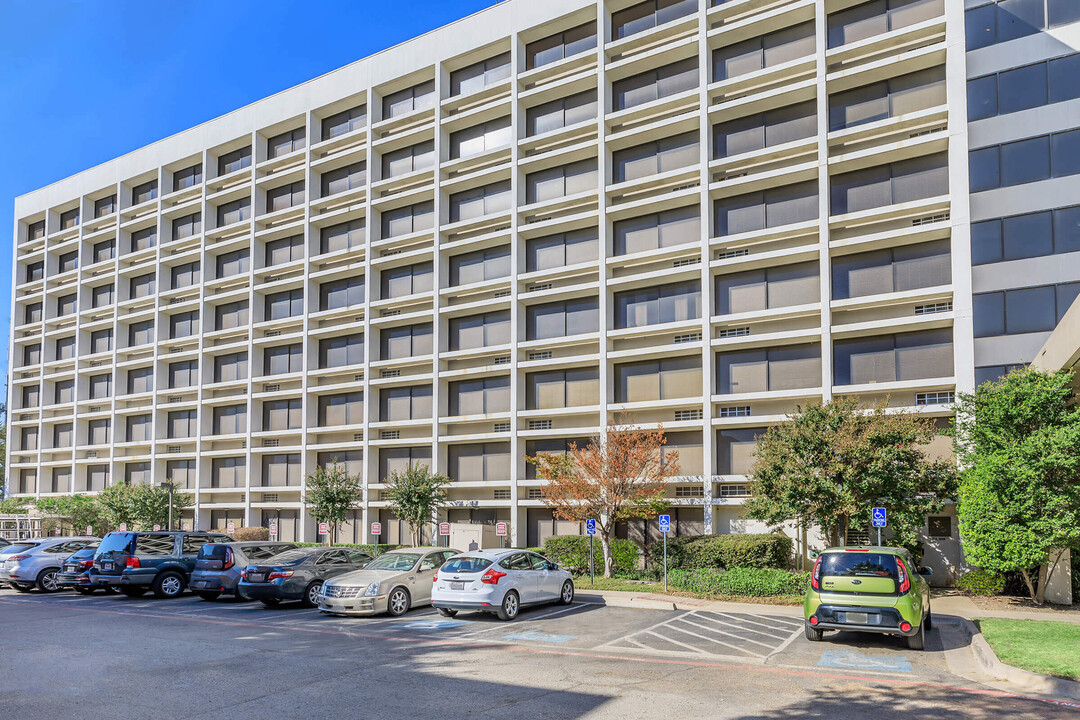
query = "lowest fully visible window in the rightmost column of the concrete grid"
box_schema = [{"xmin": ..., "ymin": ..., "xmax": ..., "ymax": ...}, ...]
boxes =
[{"xmin": 833, "ymin": 329, "xmax": 953, "ymax": 385}]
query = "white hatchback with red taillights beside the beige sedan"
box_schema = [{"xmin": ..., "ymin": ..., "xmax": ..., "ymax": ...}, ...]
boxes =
[{"xmin": 431, "ymin": 549, "xmax": 573, "ymax": 620}]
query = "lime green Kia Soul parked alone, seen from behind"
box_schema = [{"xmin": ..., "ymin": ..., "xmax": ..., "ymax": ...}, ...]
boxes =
[{"xmin": 802, "ymin": 547, "xmax": 931, "ymax": 650}]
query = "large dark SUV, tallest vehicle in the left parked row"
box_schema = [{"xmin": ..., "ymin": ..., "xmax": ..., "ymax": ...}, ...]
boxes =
[{"xmin": 91, "ymin": 531, "xmax": 232, "ymax": 598}]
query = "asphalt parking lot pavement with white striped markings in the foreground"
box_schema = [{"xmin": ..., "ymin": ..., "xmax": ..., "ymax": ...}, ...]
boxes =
[{"xmin": 0, "ymin": 589, "xmax": 1080, "ymax": 720}]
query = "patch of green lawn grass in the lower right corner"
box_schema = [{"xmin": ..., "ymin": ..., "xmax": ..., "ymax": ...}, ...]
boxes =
[{"xmin": 975, "ymin": 617, "xmax": 1080, "ymax": 680}]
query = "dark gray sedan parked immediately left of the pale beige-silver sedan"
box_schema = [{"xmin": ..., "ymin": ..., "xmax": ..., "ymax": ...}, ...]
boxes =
[{"xmin": 237, "ymin": 547, "xmax": 372, "ymax": 608}]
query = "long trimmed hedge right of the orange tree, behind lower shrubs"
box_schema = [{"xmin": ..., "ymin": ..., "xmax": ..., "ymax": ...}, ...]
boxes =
[{"xmin": 649, "ymin": 533, "xmax": 792, "ymax": 570}]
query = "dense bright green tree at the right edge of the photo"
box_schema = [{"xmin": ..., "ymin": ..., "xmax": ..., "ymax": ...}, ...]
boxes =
[{"xmin": 955, "ymin": 368, "xmax": 1080, "ymax": 603}]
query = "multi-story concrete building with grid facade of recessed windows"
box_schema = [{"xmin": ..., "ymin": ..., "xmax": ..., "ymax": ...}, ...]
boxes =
[{"xmin": 8, "ymin": 0, "xmax": 1080, "ymax": 557}]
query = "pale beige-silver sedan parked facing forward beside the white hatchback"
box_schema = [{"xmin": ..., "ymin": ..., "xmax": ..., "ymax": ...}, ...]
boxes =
[{"xmin": 319, "ymin": 547, "xmax": 460, "ymax": 615}]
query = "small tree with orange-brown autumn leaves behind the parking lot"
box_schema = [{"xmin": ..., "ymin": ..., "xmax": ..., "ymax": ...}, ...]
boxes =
[{"xmin": 525, "ymin": 418, "xmax": 678, "ymax": 578}]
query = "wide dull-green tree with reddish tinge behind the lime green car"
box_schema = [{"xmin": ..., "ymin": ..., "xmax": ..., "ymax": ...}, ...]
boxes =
[{"xmin": 745, "ymin": 397, "xmax": 956, "ymax": 549}]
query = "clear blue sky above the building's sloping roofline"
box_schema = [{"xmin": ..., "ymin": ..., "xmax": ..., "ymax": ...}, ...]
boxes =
[{"xmin": 0, "ymin": 0, "xmax": 495, "ymax": 377}]
